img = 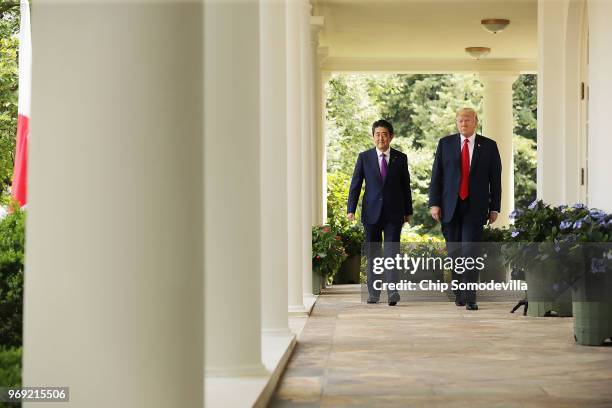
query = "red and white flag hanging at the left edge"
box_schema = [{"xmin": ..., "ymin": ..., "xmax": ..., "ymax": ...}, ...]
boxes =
[{"xmin": 11, "ymin": 0, "xmax": 32, "ymax": 207}]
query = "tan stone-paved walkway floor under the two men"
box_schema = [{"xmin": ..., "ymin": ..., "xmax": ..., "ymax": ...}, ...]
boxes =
[{"xmin": 270, "ymin": 285, "xmax": 612, "ymax": 408}]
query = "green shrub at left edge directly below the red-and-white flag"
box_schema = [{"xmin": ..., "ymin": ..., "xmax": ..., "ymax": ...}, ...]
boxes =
[{"xmin": 0, "ymin": 210, "xmax": 25, "ymax": 347}]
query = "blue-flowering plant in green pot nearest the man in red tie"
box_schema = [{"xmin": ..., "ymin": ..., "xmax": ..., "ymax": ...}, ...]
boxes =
[{"xmin": 503, "ymin": 200, "xmax": 572, "ymax": 317}]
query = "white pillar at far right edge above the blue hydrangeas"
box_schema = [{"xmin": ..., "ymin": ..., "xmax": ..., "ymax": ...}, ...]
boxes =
[{"xmin": 587, "ymin": 0, "xmax": 612, "ymax": 211}]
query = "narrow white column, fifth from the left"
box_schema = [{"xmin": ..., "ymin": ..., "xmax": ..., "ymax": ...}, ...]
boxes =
[{"xmin": 300, "ymin": 0, "xmax": 314, "ymax": 297}]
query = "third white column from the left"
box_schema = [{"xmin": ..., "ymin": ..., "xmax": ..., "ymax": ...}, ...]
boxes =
[{"xmin": 260, "ymin": 1, "xmax": 291, "ymax": 335}]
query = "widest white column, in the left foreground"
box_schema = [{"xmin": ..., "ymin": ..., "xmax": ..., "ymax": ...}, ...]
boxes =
[{"xmin": 23, "ymin": 1, "xmax": 204, "ymax": 408}]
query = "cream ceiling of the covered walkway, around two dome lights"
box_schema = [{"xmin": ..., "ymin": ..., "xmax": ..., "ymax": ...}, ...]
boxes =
[{"xmin": 314, "ymin": 0, "xmax": 537, "ymax": 60}]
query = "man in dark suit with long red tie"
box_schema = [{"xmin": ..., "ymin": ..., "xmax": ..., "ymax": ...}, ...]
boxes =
[{"xmin": 429, "ymin": 108, "xmax": 501, "ymax": 310}]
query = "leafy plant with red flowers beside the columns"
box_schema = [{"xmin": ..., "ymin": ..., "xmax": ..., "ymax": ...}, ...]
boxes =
[{"xmin": 312, "ymin": 225, "xmax": 346, "ymax": 294}]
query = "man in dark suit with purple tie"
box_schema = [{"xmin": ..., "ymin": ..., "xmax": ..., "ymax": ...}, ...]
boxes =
[{"xmin": 347, "ymin": 120, "xmax": 412, "ymax": 306}]
